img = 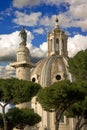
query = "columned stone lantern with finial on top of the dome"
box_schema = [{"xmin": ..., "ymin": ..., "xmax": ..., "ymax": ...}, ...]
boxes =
[{"xmin": 47, "ymin": 18, "xmax": 68, "ymax": 57}]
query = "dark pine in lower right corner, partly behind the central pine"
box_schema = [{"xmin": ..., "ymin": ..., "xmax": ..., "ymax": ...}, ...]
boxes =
[{"xmin": 65, "ymin": 81, "xmax": 87, "ymax": 130}]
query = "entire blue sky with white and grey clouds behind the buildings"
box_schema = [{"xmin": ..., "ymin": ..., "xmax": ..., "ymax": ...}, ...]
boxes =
[{"xmin": 0, "ymin": 0, "xmax": 87, "ymax": 77}]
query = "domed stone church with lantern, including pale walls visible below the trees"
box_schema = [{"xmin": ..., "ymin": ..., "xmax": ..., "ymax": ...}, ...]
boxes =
[{"xmin": 31, "ymin": 19, "xmax": 73, "ymax": 130}]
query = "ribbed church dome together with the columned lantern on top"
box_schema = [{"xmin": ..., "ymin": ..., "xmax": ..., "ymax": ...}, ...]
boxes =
[{"xmin": 31, "ymin": 19, "xmax": 69, "ymax": 87}]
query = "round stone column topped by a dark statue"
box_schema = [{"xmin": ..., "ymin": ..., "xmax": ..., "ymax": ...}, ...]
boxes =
[{"xmin": 11, "ymin": 27, "xmax": 34, "ymax": 80}]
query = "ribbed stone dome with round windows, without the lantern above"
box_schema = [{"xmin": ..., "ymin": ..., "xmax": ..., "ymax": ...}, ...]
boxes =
[{"xmin": 31, "ymin": 55, "xmax": 68, "ymax": 87}]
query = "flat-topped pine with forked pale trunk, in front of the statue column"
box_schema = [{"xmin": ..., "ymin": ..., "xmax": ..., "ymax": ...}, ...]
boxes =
[{"xmin": 0, "ymin": 78, "xmax": 41, "ymax": 130}]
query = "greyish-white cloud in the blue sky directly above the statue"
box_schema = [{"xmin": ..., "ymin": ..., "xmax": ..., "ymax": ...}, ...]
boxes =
[{"xmin": 13, "ymin": 11, "xmax": 41, "ymax": 26}]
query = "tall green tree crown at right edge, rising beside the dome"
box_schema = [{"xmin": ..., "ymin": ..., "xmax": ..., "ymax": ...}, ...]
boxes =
[{"xmin": 68, "ymin": 50, "xmax": 87, "ymax": 80}]
